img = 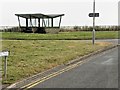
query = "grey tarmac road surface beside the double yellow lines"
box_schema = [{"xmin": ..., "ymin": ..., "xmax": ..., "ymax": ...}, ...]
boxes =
[{"xmin": 30, "ymin": 48, "xmax": 118, "ymax": 88}]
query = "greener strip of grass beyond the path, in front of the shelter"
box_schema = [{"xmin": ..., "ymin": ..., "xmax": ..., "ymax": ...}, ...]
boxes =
[{"xmin": 2, "ymin": 31, "xmax": 118, "ymax": 40}]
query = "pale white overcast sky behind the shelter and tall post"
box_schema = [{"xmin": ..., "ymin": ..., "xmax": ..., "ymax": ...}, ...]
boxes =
[{"xmin": 0, "ymin": 0, "xmax": 119, "ymax": 26}]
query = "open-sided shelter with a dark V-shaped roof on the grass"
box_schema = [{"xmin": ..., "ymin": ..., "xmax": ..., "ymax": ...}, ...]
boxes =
[{"xmin": 15, "ymin": 13, "xmax": 64, "ymax": 33}]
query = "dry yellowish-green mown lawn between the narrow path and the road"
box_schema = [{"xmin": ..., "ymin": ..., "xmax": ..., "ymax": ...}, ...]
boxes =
[{"xmin": 2, "ymin": 40, "xmax": 111, "ymax": 84}]
